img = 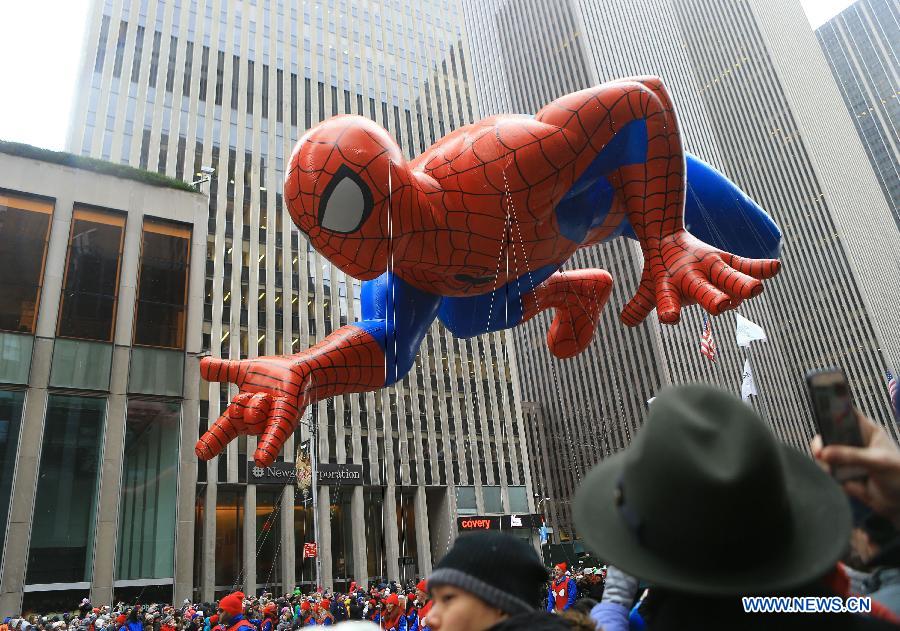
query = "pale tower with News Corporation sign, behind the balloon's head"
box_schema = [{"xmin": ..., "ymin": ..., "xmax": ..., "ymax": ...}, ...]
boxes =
[{"xmin": 68, "ymin": 0, "xmax": 534, "ymax": 599}]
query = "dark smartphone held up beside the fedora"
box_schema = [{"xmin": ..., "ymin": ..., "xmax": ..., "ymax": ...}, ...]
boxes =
[{"xmin": 806, "ymin": 368, "xmax": 866, "ymax": 482}]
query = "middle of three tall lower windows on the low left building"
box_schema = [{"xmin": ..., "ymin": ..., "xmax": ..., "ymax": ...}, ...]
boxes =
[{"xmin": 25, "ymin": 394, "xmax": 106, "ymax": 585}]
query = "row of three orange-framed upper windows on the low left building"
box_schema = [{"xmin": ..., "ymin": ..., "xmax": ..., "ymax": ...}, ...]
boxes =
[{"xmin": 0, "ymin": 193, "xmax": 190, "ymax": 349}]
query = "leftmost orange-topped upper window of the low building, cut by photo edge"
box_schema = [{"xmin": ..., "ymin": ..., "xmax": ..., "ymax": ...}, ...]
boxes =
[{"xmin": 0, "ymin": 194, "xmax": 53, "ymax": 333}]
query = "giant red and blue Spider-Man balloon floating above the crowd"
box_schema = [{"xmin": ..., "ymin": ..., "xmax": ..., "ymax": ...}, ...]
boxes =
[{"xmin": 196, "ymin": 77, "xmax": 781, "ymax": 466}]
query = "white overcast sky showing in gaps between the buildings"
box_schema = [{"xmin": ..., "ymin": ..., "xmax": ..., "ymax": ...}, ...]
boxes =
[{"xmin": 0, "ymin": 0, "xmax": 851, "ymax": 149}]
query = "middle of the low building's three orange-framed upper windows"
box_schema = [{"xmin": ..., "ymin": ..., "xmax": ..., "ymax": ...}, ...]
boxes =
[{"xmin": 57, "ymin": 208, "xmax": 125, "ymax": 342}]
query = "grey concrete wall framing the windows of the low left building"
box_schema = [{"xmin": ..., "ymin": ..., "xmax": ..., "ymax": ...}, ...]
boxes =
[{"xmin": 0, "ymin": 153, "xmax": 206, "ymax": 613}]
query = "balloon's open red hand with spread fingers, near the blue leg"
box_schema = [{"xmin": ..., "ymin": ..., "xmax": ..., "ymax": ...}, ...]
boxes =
[{"xmin": 622, "ymin": 229, "xmax": 781, "ymax": 326}]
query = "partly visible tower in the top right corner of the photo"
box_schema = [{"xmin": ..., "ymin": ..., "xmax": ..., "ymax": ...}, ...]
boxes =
[{"xmin": 816, "ymin": 0, "xmax": 900, "ymax": 229}]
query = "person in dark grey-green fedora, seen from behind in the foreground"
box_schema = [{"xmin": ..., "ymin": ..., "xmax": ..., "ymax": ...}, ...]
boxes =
[{"xmin": 574, "ymin": 385, "xmax": 895, "ymax": 631}]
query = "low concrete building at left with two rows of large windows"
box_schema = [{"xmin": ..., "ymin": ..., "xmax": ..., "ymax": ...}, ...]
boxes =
[{"xmin": 0, "ymin": 143, "xmax": 206, "ymax": 614}]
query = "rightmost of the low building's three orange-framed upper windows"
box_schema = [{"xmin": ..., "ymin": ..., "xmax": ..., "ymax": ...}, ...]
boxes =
[{"xmin": 134, "ymin": 221, "xmax": 191, "ymax": 349}]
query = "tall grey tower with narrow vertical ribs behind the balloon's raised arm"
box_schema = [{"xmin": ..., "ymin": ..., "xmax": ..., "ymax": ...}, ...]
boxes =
[{"xmin": 464, "ymin": 0, "xmax": 900, "ymax": 537}]
